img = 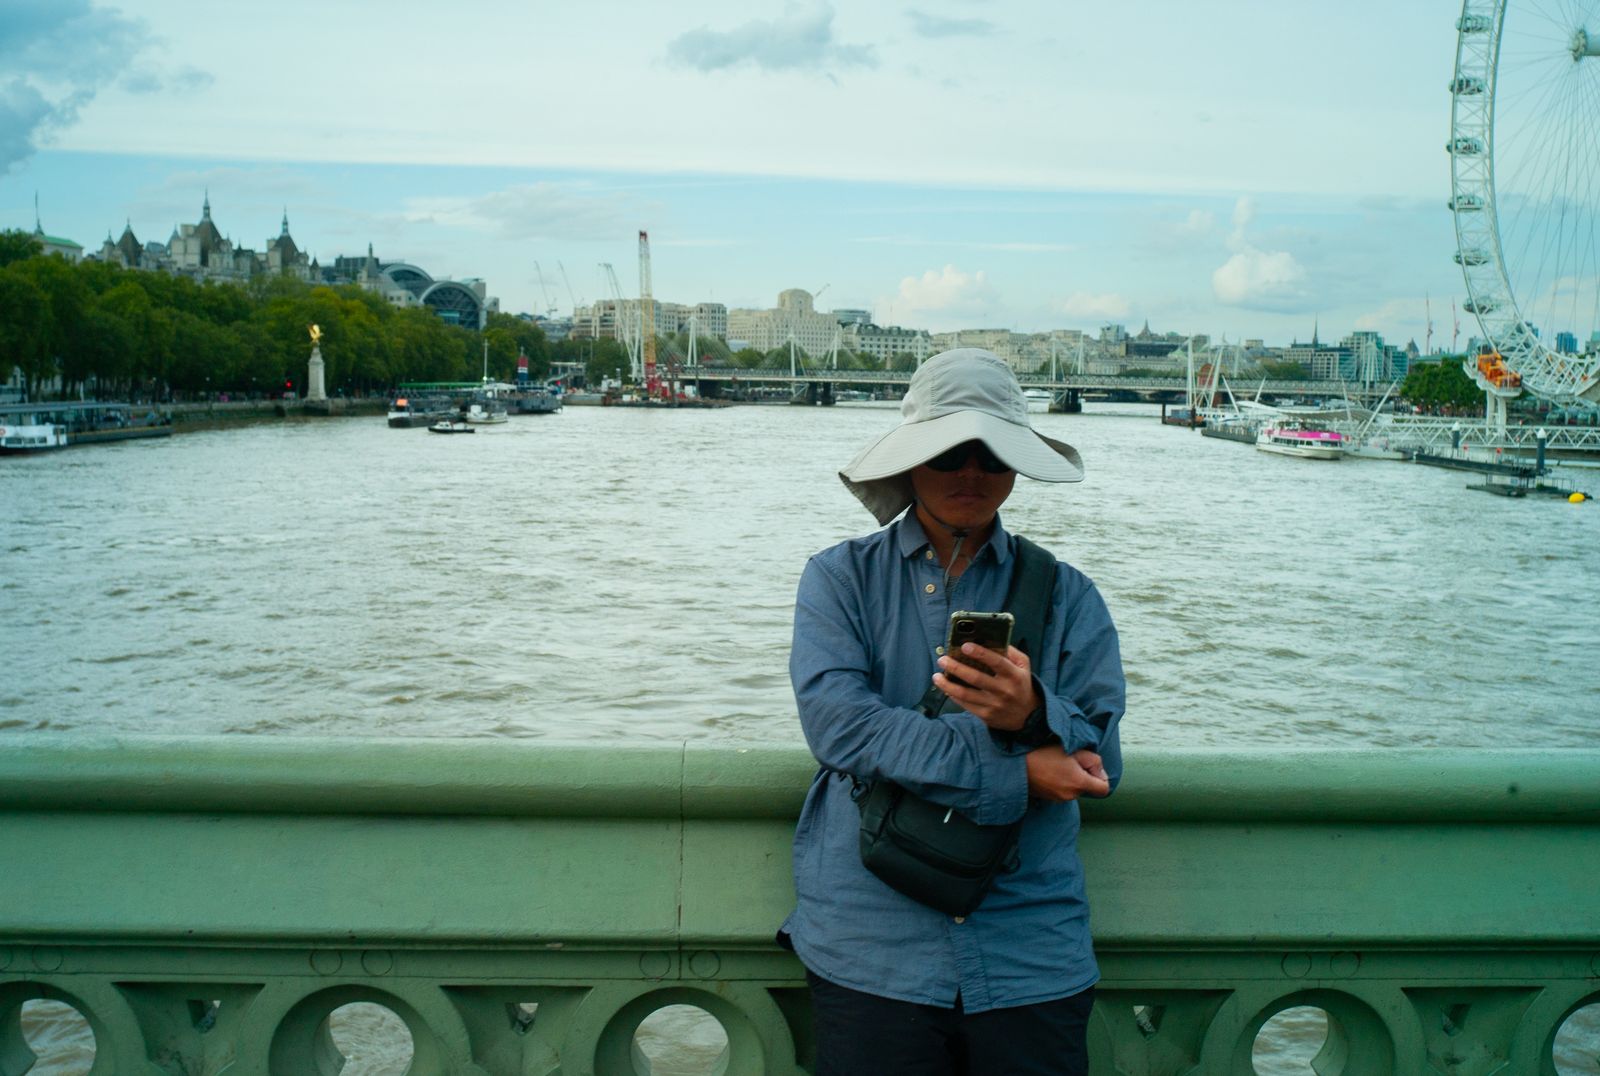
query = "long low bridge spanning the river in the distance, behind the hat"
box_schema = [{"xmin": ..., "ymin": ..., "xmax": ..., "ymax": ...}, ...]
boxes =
[{"xmin": 674, "ymin": 365, "xmax": 1397, "ymax": 412}]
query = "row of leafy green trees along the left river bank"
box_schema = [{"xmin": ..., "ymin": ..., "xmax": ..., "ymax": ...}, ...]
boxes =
[{"xmin": 0, "ymin": 231, "xmax": 568, "ymax": 400}]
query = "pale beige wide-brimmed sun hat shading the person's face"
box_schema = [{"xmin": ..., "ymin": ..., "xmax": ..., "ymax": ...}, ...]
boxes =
[{"xmin": 838, "ymin": 347, "xmax": 1083, "ymax": 524}]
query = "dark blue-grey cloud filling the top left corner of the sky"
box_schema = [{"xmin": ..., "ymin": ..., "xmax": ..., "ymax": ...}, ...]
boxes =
[{"xmin": 0, "ymin": 0, "xmax": 211, "ymax": 175}]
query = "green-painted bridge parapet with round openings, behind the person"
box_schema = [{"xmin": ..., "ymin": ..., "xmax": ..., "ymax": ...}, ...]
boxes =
[{"xmin": 0, "ymin": 733, "xmax": 1600, "ymax": 1076}]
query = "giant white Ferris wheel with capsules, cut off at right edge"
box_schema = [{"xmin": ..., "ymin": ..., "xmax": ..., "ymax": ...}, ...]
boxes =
[{"xmin": 1446, "ymin": 0, "xmax": 1600, "ymax": 405}]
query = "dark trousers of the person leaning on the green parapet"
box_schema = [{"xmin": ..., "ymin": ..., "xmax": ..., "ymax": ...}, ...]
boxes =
[{"xmin": 806, "ymin": 972, "xmax": 1094, "ymax": 1076}]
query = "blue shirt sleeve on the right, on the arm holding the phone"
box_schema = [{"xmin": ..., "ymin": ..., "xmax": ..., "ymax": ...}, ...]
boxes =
[{"xmin": 1045, "ymin": 565, "xmax": 1128, "ymax": 789}]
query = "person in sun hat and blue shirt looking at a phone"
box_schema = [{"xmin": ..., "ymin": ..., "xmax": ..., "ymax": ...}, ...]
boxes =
[{"xmin": 779, "ymin": 347, "xmax": 1125, "ymax": 1076}]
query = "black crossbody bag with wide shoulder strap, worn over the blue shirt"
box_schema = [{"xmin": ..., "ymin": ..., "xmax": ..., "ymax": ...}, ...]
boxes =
[{"xmin": 851, "ymin": 535, "xmax": 1056, "ymax": 916}]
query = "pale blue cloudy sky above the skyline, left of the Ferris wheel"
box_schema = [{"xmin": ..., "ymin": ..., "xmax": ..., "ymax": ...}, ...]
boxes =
[{"xmin": 0, "ymin": 0, "xmax": 1497, "ymax": 346}]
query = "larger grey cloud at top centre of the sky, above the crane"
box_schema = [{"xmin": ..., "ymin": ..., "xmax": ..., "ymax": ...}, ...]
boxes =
[{"xmin": 667, "ymin": 3, "xmax": 878, "ymax": 74}]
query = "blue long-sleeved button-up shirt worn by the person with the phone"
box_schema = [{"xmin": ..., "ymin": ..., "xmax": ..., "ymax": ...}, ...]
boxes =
[{"xmin": 784, "ymin": 512, "xmax": 1125, "ymax": 1012}]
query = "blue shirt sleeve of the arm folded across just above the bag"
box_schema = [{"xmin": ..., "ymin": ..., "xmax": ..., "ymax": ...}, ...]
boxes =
[{"xmin": 789, "ymin": 557, "xmax": 1027, "ymax": 825}]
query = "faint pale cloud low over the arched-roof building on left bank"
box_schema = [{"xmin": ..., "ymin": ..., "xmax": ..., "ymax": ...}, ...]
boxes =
[{"xmin": 403, "ymin": 183, "xmax": 643, "ymax": 240}]
